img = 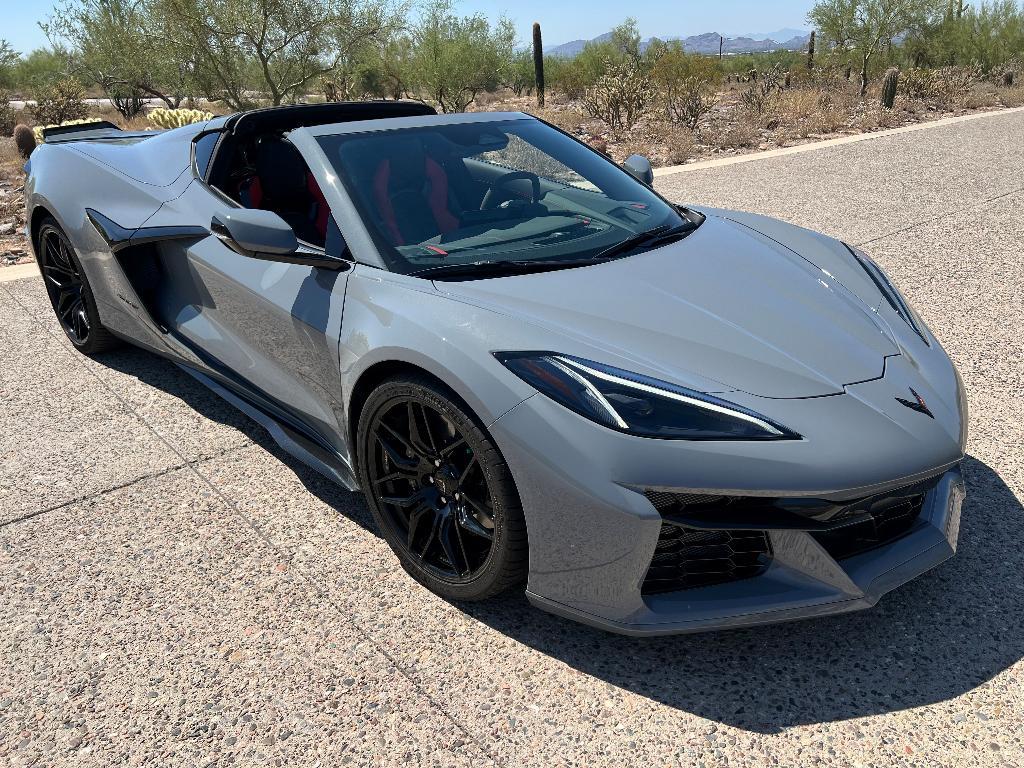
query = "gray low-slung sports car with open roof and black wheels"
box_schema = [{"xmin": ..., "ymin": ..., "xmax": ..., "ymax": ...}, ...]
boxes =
[{"xmin": 26, "ymin": 101, "xmax": 967, "ymax": 635}]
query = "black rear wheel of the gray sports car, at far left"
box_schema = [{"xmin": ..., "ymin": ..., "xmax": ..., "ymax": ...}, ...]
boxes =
[{"xmin": 36, "ymin": 216, "xmax": 122, "ymax": 355}]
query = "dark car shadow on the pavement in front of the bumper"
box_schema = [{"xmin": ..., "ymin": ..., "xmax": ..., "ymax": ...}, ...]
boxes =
[{"xmin": 463, "ymin": 458, "xmax": 1024, "ymax": 733}]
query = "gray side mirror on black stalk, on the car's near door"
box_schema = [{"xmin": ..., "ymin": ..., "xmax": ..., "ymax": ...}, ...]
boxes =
[{"xmin": 210, "ymin": 208, "xmax": 349, "ymax": 269}]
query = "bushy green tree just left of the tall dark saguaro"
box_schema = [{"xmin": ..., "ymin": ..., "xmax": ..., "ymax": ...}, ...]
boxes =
[{"xmin": 407, "ymin": 0, "xmax": 515, "ymax": 113}]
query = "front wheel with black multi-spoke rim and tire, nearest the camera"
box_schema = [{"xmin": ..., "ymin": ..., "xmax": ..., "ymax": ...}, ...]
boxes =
[{"xmin": 356, "ymin": 376, "xmax": 527, "ymax": 600}]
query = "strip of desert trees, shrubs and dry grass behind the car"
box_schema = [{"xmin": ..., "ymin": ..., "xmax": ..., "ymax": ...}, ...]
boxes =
[{"xmin": 0, "ymin": 0, "xmax": 1024, "ymax": 175}]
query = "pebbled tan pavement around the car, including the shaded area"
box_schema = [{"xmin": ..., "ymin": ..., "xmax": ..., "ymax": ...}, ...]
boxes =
[{"xmin": 0, "ymin": 114, "xmax": 1024, "ymax": 767}]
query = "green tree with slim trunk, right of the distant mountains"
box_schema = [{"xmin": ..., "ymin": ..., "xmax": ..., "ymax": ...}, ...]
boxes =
[{"xmin": 807, "ymin": 0, "xmax": 945, "ymax": 96}]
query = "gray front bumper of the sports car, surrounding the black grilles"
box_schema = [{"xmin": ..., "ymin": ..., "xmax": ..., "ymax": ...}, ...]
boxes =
[{"xmin": 490, "ymin": 360, "xmax": 965, "ymax": 636}]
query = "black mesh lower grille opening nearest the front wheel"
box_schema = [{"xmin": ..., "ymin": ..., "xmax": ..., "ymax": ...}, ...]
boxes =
[{"xmin": 642, "ymin": 523, "xmax": 771, "ymax": 595}]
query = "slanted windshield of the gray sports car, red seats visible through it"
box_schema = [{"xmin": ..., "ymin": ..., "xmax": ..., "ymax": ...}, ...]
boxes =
[{"xmin": 318, "ymin": 119, "xmax": 692, "ymax": 274}]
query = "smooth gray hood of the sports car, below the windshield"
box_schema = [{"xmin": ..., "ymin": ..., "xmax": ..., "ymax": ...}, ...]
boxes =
[{"xmin": 437, "ymin": 215, "xmax": 899, "ymax": 398}]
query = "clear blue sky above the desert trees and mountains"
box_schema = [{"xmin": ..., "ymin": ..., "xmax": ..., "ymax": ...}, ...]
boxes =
[{"xmin": 0, "ymin": 0, "xmax": 813, "ymax": 52}]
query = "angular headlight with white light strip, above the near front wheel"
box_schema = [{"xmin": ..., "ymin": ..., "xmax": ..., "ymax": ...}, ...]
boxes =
[{"xmin": 495, "ymin": 352, "xmax": 800, "ymax": 440}]
